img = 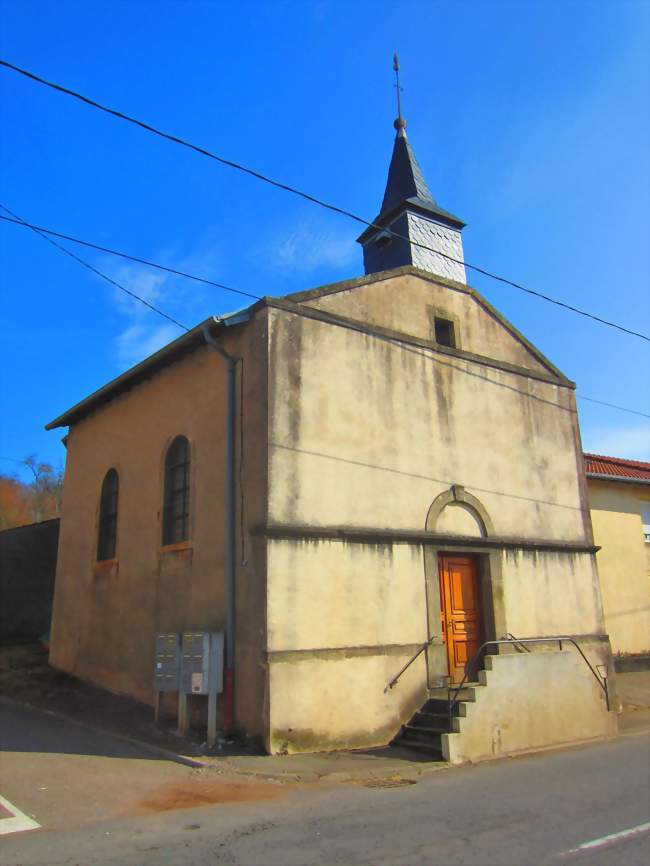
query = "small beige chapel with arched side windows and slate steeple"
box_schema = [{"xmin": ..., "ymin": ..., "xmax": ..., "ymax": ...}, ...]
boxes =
[{"xmin": 48, "ymin": 98, "xmax": 617, "ymax": 762}]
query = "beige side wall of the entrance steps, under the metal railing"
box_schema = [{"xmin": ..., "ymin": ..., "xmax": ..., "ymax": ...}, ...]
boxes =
[{"xmin": 443, "ymin": 647, "xmax": 617, "ymax": 764}]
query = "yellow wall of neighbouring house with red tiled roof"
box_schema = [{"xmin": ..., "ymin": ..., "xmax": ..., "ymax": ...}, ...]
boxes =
[{"xmin": 587, "ymin": 478, "xmax": 650, "ymax": 653}]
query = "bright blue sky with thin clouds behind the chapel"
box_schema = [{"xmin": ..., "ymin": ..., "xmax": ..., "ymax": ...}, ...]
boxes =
[{"xmin": 0, "ymin": 0, "xmax": 650, "ymax": 480}]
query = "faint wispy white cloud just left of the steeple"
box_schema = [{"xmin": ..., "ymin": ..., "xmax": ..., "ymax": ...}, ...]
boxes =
[{"xmin": 260, "ymin": 217, "xmax": 358, "ymax": 274}]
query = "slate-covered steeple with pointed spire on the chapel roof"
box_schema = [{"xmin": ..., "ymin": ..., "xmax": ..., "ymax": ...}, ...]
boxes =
[{"xmin": 357, "ymin": 54, "xmax": 465, "ymax": 283}]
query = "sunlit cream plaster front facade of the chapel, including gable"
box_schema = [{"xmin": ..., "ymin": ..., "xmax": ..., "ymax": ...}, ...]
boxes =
[{"xmin": 267, "ymin": 273, "xmax": 604, "ymax": 751}]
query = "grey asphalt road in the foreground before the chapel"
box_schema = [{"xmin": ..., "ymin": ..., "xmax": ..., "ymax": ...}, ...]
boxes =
[{"xmin": 0, "ymin": 712, "xmax": 650, "ymax": 866}]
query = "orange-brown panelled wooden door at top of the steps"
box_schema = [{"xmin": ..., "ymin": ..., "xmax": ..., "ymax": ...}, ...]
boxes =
[{"xmin": 438, "ymin": 554, "xmax": 484, "ymax": 683}]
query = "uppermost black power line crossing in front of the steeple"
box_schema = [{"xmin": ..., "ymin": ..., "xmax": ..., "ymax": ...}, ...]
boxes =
[{"xmin": 0, "ymin": 59, "xmax": 650, "ymax": 342}]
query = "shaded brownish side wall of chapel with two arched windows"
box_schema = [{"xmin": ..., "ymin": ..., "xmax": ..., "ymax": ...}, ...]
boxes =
[{"xmin": 51, "ymin": 317, "xmax": 267, "ymax": 735}]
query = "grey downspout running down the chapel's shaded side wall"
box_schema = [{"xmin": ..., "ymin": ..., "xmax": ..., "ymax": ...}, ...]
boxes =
[{"xmin": 203, "ymin": 319, "xmax": 240, "ymax": 731}]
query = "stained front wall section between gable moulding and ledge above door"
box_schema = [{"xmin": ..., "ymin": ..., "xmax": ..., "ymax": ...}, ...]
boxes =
[{"xmin": 269, "ymin": 296, "xmax": 590, "ymax": 541}]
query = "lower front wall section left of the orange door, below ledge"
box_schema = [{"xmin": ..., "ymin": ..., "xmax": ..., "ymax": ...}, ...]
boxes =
[{"xmin": 268, "ymin": 540, "xmax": 427, "ymax": 751}]
